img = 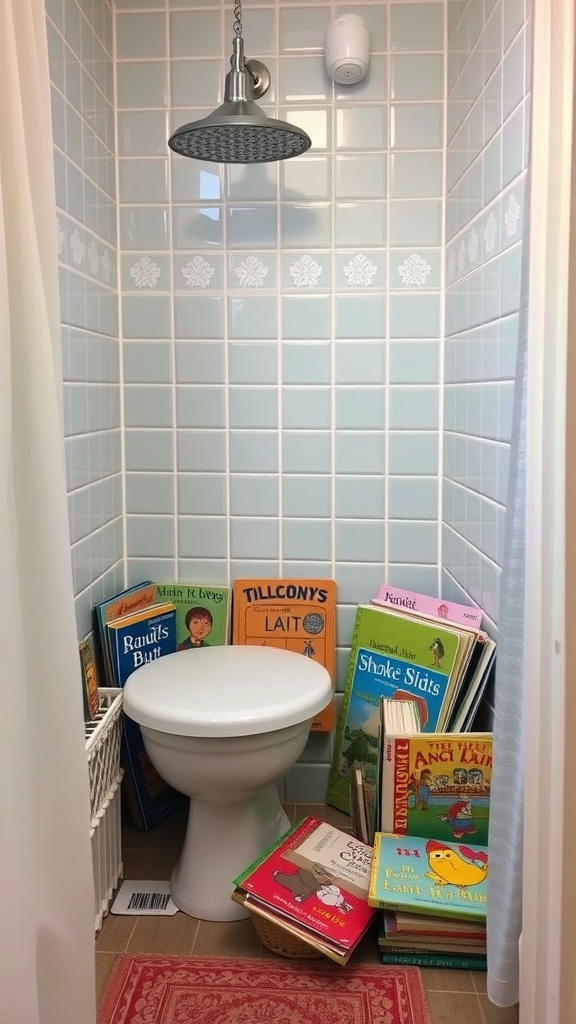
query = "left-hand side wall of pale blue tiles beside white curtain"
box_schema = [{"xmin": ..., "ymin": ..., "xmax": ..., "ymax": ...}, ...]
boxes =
[{"xmin": 46, "ymin": 0, "xmax": 124, "ymax": 636}]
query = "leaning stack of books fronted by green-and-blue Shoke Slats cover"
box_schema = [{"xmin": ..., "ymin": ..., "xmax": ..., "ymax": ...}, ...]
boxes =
[{"xmin": 327, "ymin": 586, "xmax": 496, "ymax": 826}]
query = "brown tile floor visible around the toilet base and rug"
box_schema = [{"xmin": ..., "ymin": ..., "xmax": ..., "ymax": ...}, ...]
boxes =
[{"xmin": 96, "ymin": 804, "xmax": 519, "ymax": 1024}]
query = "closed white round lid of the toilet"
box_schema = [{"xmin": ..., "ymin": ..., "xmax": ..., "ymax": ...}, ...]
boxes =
[{"xmin": 123, "ymin": 646, "xmax": 332, "ymax": 736}]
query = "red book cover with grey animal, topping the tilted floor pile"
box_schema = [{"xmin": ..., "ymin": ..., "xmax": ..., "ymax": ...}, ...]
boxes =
[{"xmin": 237, "ymin": 817, "xmax": 374, "ymax": 949}]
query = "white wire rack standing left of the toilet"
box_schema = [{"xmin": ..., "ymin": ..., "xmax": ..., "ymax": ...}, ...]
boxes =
[{"xmin": 85, "ymin": 687, "xmax": 124, "ymax": 932}]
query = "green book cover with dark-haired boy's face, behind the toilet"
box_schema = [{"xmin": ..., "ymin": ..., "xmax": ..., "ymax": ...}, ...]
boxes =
[{"xmin": 156, "ymin": 583, "xmax": 232, "ymax": 650}]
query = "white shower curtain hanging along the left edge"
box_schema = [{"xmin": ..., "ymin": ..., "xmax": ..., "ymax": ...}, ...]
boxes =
[{"xmin": 0, "ymin": 0, "xmax": 95, "ymax": 1024}]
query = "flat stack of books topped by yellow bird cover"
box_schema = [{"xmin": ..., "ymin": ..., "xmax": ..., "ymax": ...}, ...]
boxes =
[{"xmin": 368, "ymin": 833, "xmax": 488, "ymax": 971}]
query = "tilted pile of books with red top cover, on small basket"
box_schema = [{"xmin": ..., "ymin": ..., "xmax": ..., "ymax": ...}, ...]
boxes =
[{"xmin": 232, "ymin": 816, "xmax": 376, "ymax": 964}]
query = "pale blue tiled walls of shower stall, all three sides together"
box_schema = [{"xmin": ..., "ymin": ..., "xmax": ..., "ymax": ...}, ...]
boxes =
[{"xmin": 46, "ymin": 0, "xmax": 529, "ymax": 800}]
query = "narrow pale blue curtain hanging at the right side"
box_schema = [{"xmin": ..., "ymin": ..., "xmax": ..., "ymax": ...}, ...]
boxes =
[{"xmin": 487, "ymin": 171, "xmax": 530, "ymax": 1007}]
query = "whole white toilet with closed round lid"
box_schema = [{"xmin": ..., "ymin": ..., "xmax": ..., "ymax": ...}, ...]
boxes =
[{"xmin": 124, "ymin": 646, "xmax": 332, "ymax": 921}]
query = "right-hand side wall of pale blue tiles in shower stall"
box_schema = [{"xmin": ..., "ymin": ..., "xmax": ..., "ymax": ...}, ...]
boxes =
[{"xmin": 442, "ymin": 0, "xmax": 531, "ymax": 627}]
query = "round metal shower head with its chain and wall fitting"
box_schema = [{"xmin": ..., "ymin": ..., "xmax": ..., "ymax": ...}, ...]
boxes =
[{"xmin": 168, "ymin": 0, "xmax": 312, "ymax": 164}]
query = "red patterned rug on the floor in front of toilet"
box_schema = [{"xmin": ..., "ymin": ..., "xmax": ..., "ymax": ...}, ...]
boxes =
[{"xmin": 98, "ymin": 953, "xmax": 430, "ymax": 1024}]
